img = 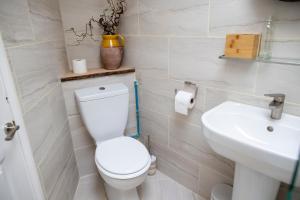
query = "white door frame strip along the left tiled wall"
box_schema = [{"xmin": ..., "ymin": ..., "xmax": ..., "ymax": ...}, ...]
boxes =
[{"xmin": 0, "ymin": 32, "xmax": 45, "ymax": 200}]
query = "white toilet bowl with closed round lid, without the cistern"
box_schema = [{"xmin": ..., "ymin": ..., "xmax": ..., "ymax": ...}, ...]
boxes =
[{"xmin": 95, "ymin": 136, "xmax": 151, "ymax": 200}]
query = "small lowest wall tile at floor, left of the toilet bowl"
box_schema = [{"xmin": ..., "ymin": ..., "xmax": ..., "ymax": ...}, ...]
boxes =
[{"xmin": 75, "ymin": 145, "xmax": 98, "ymax": 177}]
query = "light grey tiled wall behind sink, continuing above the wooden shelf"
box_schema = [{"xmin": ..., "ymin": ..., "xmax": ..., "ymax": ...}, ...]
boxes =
[{"xmin": 60, "ymin": 0, "xmax": 300, "ymax": 197}]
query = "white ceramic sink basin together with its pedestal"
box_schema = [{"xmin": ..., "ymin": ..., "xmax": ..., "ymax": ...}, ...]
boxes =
[{"xmin": 202, "ymin": 101, "xmax": 300, "ymax": 200}]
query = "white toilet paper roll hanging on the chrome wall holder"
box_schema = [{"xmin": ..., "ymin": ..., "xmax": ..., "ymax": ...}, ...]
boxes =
[{"xmin": 175, "ymin": 90, "xmax": 195, "ymax": 115}]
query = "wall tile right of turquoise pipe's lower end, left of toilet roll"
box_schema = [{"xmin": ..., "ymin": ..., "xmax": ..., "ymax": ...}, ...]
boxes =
[{"xmin": 141, "ymin": 108, "xmax": 168, "ymax": 145}]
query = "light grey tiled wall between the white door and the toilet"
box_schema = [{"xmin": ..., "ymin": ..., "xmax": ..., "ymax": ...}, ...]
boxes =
[{"xmin": 0, "ymin": 0, "xmax": 79, "ymax": 200}]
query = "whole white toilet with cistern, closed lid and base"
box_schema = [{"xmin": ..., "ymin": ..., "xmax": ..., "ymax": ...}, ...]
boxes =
[{"xmin": 75, "ymin": 84, "xmax": 151, "ymax": 200}]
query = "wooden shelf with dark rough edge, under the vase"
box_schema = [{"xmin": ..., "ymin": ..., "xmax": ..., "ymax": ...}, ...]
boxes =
[{"xmin": 61, "ymin": 67, "xmax": 135, "ymax": 82}]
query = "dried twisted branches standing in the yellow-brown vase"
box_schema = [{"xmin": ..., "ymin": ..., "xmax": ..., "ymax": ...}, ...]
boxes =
[{"xmin": 66, "ymin": 0, "xmax": 127, "ymax": 45}]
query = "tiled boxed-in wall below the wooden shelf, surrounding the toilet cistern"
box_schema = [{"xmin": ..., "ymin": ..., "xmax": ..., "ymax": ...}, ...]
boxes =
[{"xmin": 62, "ymin": 73, "xmax": 136, "ymax": 177}]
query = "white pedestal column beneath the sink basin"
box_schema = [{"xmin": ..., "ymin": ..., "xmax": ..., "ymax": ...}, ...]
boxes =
[{"xmin": 232, "ymin": 163, "xmax": 280, "ymax": 200}]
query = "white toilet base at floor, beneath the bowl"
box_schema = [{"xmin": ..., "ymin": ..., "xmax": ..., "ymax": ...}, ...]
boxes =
[{"xmin": 104, "ymin": 183, "xmax": 140, "ymax": 200}]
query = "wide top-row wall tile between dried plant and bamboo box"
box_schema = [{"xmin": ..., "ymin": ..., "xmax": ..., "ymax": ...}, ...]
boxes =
[{"xmin": 140, "ymin": 0, "xmax": 208, "ymax": 35}]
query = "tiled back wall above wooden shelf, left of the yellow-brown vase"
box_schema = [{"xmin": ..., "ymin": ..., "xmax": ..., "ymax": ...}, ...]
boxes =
[{"xmin": 59, "ymin": 0, "xmax": 106, "ymax": 69}]
